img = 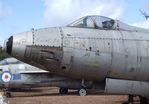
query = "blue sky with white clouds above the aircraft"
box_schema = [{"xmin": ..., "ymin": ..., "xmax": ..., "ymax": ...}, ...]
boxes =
[{"xmin": 0, "ymin": 0, "xmax": 149, "ymax": 45}]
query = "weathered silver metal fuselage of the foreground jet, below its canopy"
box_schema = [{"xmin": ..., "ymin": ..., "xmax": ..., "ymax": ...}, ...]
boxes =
[{"xmin": 7, "ymin": 27, "xmax": 149, "ymax": 81}]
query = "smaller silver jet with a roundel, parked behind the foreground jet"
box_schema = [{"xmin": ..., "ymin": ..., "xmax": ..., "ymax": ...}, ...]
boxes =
[{"xmin": 0, "ymin": 58, "xmax": 97, "ymax": 97}]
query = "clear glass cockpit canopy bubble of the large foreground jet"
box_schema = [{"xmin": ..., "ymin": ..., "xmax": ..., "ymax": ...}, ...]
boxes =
[{"xmin": 68, "ymin": 16, "xmax": 115, "ymax": 29}]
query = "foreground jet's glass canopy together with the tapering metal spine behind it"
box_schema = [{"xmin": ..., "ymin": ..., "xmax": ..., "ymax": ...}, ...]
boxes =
[{"xmin": 67, "ymin": 15, "xmax": 149, "ymax": 33}]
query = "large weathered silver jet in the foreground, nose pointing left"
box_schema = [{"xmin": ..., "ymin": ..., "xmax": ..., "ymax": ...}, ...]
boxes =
[{"xmin": 5, "ymin": 15, "xmax": 149, "ymax": 104}]
